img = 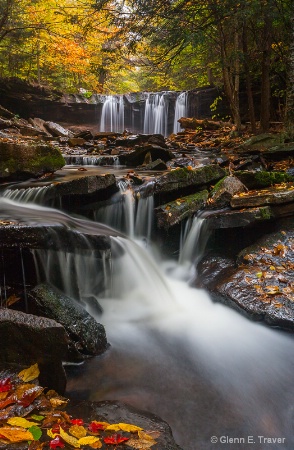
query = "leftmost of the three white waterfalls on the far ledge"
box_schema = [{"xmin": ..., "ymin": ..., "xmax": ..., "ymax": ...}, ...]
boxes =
[{"xmin": 100, "ymin": 95, "xmax": 125, "ymax": 133}]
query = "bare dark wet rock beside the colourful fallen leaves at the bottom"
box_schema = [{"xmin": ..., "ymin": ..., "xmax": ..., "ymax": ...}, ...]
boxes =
[{"xmin": 67, "ymin": 401, "xmax": 181, "ymax": 450}]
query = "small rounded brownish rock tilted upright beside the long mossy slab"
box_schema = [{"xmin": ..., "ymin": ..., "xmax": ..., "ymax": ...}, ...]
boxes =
[{"xmin": 210, "ymin": 176, "xmax": 247, "ymax": 208}]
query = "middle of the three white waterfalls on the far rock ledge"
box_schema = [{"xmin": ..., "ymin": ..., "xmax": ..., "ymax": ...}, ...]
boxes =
[{"xmin": 144, "ymin": 93, "xmax": 168, "ymax": 136}]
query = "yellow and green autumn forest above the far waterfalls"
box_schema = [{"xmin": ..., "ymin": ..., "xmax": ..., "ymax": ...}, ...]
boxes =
[{"xmin": 0, "ymin": 0, "xmax": 294, "ymax": 132}]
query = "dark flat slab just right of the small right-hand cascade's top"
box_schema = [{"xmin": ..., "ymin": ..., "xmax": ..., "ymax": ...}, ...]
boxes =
[{"xmin": 206, "ymin": 206, "xmax": 274, "ymax": 229}]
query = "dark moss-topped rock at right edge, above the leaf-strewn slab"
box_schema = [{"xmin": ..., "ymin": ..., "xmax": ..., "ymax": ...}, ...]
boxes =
[{"xmin": 234, "ymin": 170, "xmax": 294, "ymax": 189}]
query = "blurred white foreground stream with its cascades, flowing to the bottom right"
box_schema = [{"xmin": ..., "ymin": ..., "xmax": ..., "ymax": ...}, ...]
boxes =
[{"xmin": 0, "ymin": 194, "xmax": 294, "ymax": 450}]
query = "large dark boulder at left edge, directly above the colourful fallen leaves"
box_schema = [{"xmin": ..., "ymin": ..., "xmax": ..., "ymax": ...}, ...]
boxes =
[{"xmin": 0, "ymin": 309, "xmax": 68, "ymax": 393}]
